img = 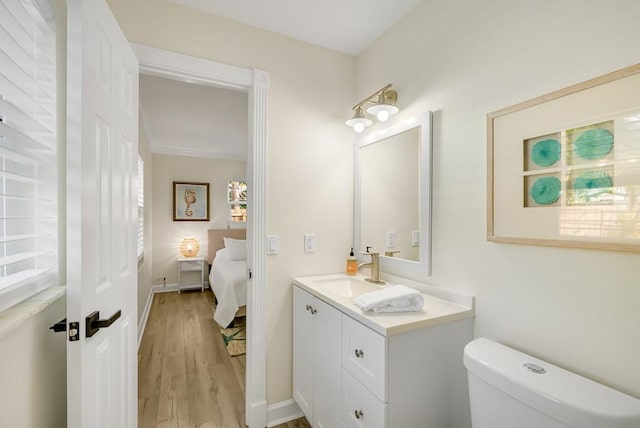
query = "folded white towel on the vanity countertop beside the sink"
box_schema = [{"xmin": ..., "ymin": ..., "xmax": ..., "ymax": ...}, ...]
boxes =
[{"xmin": 354, "ymin": 285, "xmax": 424, "ymax": 313}]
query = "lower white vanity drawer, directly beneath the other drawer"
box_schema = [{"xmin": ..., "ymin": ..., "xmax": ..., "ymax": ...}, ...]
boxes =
[{"xmin": 340, "ymin": 368, "xmax": 387, "ymax": 428}]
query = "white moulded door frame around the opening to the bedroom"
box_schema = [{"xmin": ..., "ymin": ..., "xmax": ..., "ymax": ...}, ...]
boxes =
[{"xmin": 131, "ymin": 43, "xmax": 269, "ymax": 428}]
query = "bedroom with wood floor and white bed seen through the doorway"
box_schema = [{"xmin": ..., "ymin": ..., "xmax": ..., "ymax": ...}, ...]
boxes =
[{"xmin": 138, "ymin": 66, "xmax": 251, "ymax": 427}]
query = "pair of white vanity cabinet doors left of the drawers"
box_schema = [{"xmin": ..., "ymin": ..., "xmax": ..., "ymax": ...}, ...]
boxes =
[{"xmin": 293, "ymin": 287, "xmax": 341, "ymax": 428}]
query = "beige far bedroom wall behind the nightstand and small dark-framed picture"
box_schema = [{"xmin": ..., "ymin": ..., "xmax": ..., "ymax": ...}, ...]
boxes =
[{"xmin": 151, "ymin": 154, "xmax": 247, "ymax": 285}]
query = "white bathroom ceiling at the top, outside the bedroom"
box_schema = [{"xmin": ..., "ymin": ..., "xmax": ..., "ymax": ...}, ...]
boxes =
[{"xmin": 171, "ymin": 0, "xmax": 424, "ymax": 55}]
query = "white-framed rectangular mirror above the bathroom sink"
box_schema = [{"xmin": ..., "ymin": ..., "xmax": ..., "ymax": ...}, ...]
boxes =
[{"xmin": 354, "ymin": 112, "xmax": 431, "ymax": 279}]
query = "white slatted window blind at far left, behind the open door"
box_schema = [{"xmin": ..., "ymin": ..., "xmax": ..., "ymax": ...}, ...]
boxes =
[{"xmin": 0, "ymin": 0, "xmax": 58, "ymax": 311}]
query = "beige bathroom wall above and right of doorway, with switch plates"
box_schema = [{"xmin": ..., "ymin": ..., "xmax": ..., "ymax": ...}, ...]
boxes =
[{"xmin": 109, "ymin": 0, "xmax": 355, "ymax": 403}]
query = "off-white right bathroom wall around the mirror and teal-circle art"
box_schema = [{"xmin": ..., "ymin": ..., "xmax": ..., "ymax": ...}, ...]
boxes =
[{"xmin": 357, "ymin": 0, "xmax": 640, "ymax": 398}]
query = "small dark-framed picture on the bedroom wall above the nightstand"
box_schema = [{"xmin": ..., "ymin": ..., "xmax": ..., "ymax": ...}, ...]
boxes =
[{"xmin": 173, "ymin": 181, "xmax": 209, "ymax": 221}]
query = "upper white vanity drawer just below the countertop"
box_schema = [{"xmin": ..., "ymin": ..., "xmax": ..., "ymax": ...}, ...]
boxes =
[{"xmin": 342, "ymin": 315, "xmax": 387, "ymax": 403}]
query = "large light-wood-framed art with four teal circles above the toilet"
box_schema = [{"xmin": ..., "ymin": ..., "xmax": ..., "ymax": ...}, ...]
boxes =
[{"xmin": 487, "ymin": 64, "xmax": 640, "ymax": 251}]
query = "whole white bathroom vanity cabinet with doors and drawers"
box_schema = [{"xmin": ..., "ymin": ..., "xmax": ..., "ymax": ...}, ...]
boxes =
[{"xmin": 293, "ymin": 278, "xmax": 474, "ymax": 428}]
